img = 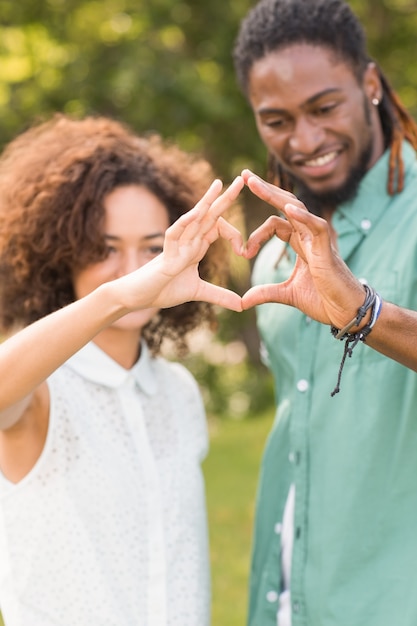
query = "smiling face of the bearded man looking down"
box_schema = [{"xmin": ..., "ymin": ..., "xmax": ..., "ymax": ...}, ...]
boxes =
[{"xmin": 248, "ymin": 44, "xmax": 384, "ymax": 213}]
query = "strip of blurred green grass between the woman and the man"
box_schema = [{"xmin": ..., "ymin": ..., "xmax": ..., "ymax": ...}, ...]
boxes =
[{"xmin": 0, "ymin": 410, "xmax": 272, "ymax": 626}]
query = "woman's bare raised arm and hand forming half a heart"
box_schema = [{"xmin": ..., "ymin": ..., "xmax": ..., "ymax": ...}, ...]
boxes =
[{"xmin": 0, "ymin": 177, "xmax": 243, "ymax": 429}]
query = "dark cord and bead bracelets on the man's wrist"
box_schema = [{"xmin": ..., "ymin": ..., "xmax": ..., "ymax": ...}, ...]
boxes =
[{"xmin": 330, "ymin": 285, "xmax": 382, "ymax": 397}]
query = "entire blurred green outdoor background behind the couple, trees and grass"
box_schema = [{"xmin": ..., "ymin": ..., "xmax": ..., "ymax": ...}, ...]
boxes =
[{"xmin": 0, "ymin": 0, "xmax": 417, "ymax": 626}]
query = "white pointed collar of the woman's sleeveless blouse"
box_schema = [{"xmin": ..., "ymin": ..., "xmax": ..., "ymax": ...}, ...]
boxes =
[{"xmin": 66, "ymin": 341, "xmax": 157, "ymax": 395}]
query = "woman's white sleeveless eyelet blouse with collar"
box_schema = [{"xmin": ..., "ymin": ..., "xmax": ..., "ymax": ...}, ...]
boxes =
[{"xmin": 0, "ymin": 343, "xmax": 210, "ymax": 626}]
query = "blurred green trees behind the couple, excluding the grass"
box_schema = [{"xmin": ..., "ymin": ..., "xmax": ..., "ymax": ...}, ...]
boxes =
[{"xmin": 0, "ymin": 0, "xmax": 417, "ymax": 410}]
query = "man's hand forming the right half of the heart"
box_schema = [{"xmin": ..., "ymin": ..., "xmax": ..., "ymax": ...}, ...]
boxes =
[{"xmin": 242, "ymin": 170, "xmax": 364, "ymax": 328}]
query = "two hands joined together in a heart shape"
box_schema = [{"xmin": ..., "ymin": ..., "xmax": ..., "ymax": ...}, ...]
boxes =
[{"xmin": 155, "ymin": 170, "xmax": 364, "ymax": 328}]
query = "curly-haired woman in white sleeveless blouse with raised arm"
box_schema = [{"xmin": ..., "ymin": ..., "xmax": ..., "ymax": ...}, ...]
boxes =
[{"xmin": 0, "ymin": 116, "xmax": 243, "ymax": 626}]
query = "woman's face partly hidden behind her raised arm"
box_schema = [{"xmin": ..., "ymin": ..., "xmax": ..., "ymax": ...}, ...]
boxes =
[{"xmin": 73, "ymin": 185, "xmax": 169, "ymax": 330}]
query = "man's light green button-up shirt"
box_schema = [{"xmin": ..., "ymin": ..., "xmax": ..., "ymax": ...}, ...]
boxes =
[{"xmin": 249, "ymin": 143, "xmax": 417, "ymax": 626}]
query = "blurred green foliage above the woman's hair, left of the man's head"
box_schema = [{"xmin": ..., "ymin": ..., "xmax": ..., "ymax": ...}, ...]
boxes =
[{"xmin": 0, "ymin": 0, "xmax": 256, "ymax": 177}]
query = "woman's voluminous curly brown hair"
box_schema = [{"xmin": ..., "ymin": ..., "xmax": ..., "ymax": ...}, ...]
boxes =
[{"xmin": 0, "ymin": 114, "xmax": 228, "ymax": 354}]
